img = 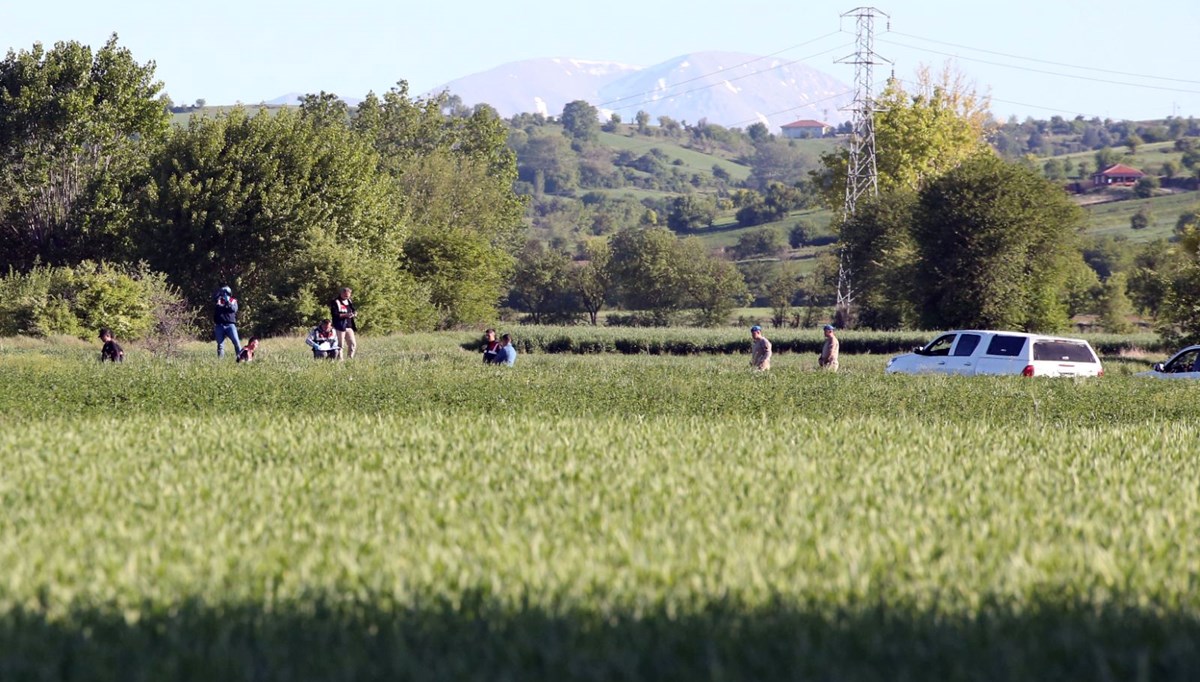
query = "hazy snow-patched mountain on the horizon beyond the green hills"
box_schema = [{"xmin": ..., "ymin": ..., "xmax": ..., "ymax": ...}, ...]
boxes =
[{"xmin": 433, "ymin": 52, "xmax": 853, "ymax": 132}]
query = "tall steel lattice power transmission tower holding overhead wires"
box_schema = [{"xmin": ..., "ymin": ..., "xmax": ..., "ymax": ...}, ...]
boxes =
[{"xmin": 838, "ymin": 7, "xmax": 892, "ymax": 319}]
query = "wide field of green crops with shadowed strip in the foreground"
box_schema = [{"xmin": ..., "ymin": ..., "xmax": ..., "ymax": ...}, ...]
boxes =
[{"xmin": 0, "ymin": 334, "xmax": 1200, "ymax": 681}]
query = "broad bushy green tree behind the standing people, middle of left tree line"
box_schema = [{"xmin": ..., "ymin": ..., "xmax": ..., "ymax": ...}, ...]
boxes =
[{"xmin": 130, "ymin": 105, "xmax": 420, "ymax": 333}]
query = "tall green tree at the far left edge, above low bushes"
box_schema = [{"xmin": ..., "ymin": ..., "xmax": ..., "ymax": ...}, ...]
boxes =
[{"xmin": 0, "ymin": 35, "xmax": 169, "ymax": 271}]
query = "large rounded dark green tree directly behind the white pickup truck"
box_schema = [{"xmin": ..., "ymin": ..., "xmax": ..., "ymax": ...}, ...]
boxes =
[{"xmin": 912, "ymin": 152, "xmax": 1084, "ymax": 331}]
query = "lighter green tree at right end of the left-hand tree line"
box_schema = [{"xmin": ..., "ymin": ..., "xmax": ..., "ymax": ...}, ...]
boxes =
[{"xmin": 354, "ymin": 82, "xmax": 524, "ymax": 327}]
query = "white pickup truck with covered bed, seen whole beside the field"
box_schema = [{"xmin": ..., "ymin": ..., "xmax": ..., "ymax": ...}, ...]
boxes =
[{"xmin": 886, "ymin": 329, "xmax": 1104, "ymax": 377}]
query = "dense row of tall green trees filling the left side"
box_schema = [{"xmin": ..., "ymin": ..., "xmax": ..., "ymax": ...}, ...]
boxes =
[{"xmin": 0, "ymin": 36, "xmax": 524, "ymax": 333}]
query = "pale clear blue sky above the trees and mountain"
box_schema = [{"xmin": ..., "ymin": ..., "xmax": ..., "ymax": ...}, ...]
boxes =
[{"xmin": 0, "ymin": 0, "xmax": 1200, "ymax": 119}]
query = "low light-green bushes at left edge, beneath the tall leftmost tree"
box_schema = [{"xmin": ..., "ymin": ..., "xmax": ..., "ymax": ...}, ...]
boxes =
[{"xmin": 0, "ymin": 261, "xmax": 180, "ymax": 341}]
